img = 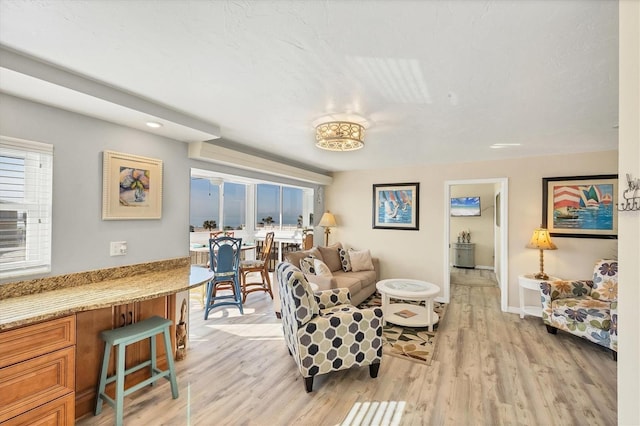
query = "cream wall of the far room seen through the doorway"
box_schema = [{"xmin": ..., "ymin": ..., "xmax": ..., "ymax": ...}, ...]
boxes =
[{"xmin": 449, "ymin": 184, "xmax": 495, "ymax": 269}]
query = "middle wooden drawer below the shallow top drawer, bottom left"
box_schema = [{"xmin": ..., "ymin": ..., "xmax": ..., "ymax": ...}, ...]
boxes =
[{"xmin": 0, "ymin": 346, "xmax": 75, "ymax": 422}]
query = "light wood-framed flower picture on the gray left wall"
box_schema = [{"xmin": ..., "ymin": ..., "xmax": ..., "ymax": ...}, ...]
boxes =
[{"xmin": 102, "ymin": 151, "xmax": 163, "ymax": 220}]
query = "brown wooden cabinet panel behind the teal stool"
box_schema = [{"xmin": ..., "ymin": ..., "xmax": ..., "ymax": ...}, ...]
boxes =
[{"xmin": 75, "ymin": 295, "xmax": 176, "ymax": 418}]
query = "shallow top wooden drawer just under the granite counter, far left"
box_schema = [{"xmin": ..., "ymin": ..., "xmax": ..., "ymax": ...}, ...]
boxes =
[{"xmin": 0, "ymin": 315, "xmax": 76, "ymax": 368}]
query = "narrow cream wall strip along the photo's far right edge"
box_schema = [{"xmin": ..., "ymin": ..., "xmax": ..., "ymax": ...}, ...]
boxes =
[{"xmin": 618, "ymin": 1, "xmax": 640, "ymax": 425}]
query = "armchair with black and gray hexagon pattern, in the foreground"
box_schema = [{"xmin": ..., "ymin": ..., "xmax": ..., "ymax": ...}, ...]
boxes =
[{"xmin": 276, "ymin": 262, "xmax": 382, "ymax": 392}]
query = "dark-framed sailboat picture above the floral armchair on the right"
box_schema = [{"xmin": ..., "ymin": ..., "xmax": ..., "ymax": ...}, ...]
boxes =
[{"xmin": 542, "ymin": 174, "xmax": 618, "ymax": 239}]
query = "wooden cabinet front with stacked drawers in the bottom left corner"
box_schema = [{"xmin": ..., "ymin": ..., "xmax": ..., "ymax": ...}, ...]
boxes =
[{"xmin": 0, "ymin": 315, "xmax": 76, "ymax": 425}]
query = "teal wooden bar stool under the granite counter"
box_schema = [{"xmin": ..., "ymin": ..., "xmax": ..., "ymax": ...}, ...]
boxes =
[{"xmin": 95, "ymin": 316, "xmax": 178, "ymax": 426}]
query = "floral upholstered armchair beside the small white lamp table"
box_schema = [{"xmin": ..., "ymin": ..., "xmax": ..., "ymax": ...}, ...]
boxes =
[{"xmin": 540, "ymin": 260, "xmax": 618, "ymax": 359}]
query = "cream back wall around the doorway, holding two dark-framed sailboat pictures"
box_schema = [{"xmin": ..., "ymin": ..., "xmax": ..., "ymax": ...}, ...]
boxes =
[{"xmin": 325, "ymin": 151, "xmax": 618, "ymax": 311}]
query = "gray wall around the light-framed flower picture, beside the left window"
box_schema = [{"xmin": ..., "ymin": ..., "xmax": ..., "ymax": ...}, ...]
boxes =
[{"xmin": 0, "ymin": 94, "xmax": 190, "ymax": 282}]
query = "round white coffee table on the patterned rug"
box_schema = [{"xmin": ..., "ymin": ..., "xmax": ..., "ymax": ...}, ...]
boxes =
[{"xmin": 376, "ymin": 278, "xmax": 440, "ymax": 331}]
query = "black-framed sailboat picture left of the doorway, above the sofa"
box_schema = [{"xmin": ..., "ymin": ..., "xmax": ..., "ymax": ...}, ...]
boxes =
[{"xmin": 372, "ymin": 182, "xmax": 420, "ymax": 231}]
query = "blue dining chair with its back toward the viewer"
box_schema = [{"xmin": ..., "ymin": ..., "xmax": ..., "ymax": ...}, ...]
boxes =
[{"xmin": 204, "ymin": 237, "xmax": 244, "ymax": 320}]
